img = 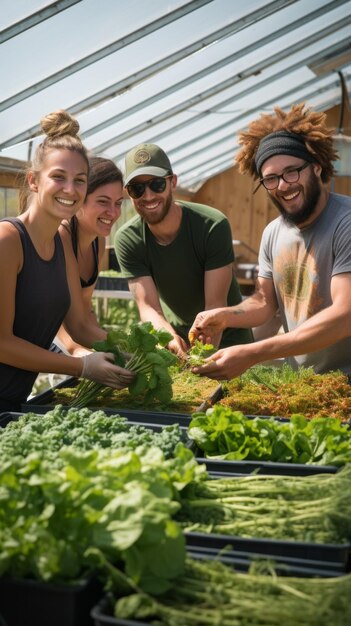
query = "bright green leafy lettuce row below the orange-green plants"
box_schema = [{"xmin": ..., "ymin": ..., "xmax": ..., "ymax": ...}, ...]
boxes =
[{"xmin": 188, "ymin": 404, "xmax": 351, "ymax": 465}]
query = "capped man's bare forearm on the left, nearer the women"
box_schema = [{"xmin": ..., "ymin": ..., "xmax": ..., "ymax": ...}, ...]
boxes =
[{"xmin": 128, "ymin": 276, "xmax": 187, "ymax": 355}]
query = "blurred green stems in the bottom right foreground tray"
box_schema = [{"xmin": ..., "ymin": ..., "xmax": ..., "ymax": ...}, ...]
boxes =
[{"xmin": 106, "ymin": 558, "xmax": 351, "ymax": 626}]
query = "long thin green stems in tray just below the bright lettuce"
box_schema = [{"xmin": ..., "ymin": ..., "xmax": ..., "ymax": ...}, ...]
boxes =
[{"xmin": 176, "ymin": 465, "xmax": 351, "ymax": 544}]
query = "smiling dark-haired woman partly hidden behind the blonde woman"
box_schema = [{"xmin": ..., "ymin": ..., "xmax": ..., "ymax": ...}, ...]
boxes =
[{"xmin": 55, "ymin": 156, "xmax": 123, "ymax": 356}]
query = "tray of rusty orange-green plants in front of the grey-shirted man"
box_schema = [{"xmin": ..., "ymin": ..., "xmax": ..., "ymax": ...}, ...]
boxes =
[{"xmin": 220, "ymin": 365, "xmax": 351, "ymax": 421}]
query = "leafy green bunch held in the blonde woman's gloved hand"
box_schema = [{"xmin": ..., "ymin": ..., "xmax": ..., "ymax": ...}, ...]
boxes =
[{"xmin": 70, "ymin": 322, "xmax": 177, "ymax": 408}]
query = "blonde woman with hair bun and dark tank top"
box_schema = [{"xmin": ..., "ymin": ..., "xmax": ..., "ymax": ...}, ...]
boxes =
[{"xmin": 0, "ymin": 110, "xmax": 133, "ymax": 411}]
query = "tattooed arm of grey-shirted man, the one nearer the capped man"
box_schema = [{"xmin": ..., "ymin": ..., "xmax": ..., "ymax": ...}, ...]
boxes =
[{"xmin": 190, "ymin": 278, "xmax": 278, "ymax": 343}]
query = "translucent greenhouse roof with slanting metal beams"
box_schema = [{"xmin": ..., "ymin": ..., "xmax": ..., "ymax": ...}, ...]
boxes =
[{"xmin": 0, "ymin": 0, "xmax": 351, "ymax": 191}]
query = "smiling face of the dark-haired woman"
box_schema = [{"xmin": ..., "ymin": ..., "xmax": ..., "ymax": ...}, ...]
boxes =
[{"xmin": 77, "ymin": 182, "xmax": 123, "ymax": 237}]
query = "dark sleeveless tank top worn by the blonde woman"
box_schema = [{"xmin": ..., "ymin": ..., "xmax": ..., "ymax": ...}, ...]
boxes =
[{"xmin": 0, "ymin": 218, "xmax": 71, "ymax": 411}]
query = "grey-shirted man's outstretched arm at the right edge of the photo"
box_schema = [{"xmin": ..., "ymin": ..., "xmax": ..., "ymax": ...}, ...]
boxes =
[{"xmin": 194, "ymin": 273, "xmax": 351, "ymax": 380}]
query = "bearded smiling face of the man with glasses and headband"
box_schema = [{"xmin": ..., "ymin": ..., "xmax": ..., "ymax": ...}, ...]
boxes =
[{"xmin": 261, "ymin": 154, "xmax": 323, "ymax": 227}]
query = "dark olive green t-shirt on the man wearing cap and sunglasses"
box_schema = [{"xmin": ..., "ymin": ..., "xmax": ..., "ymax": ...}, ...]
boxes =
[{"xmin": 115, "ymin": 202, "xmax": 252, "ymax": 347}]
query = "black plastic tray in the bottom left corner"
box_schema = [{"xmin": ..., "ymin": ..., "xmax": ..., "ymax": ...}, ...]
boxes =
[{"xmin": 0, "ymin": 577, "xmax": 104, "ymax": 626}]
